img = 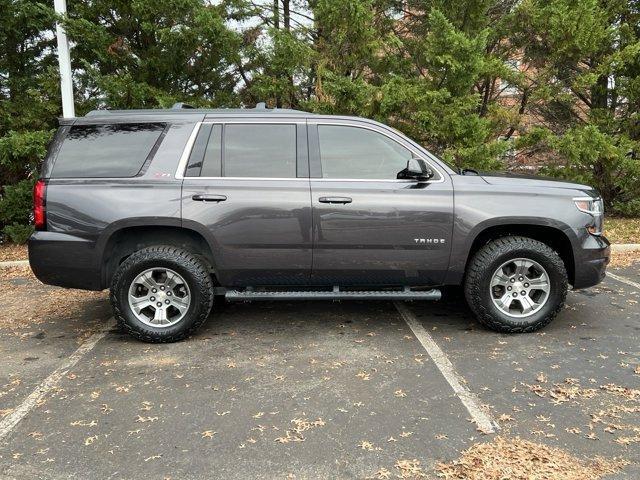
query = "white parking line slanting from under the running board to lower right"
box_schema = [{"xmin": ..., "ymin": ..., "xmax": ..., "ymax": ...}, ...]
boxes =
[{"xmin": 393, "ymin": 302, "xmax": 500, "ymax": 433}]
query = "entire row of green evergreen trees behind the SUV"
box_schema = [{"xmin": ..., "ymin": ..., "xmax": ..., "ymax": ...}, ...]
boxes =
[{"xmin": 0, "ymin": 0, "xmax": 640, "ymax": 240}]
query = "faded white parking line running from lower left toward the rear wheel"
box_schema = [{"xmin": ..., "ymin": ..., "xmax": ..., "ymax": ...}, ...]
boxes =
[{"xmin": 0, "ymin": 318, "xmax": 114, "ymax": 441}]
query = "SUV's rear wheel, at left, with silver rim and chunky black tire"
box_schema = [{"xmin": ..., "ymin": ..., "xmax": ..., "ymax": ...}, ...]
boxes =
[{"xmin": 110, "ymin": 246, "xmax": 213, "ymax": 343}]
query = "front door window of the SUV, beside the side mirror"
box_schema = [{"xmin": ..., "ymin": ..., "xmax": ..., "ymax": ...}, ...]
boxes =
[{"xmin": 318, "ymin": 125, "xmax": 412, "ymax": 180}]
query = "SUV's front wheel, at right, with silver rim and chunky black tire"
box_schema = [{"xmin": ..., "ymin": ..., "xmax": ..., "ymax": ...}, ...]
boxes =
[{"xmin": 464, "ymin": 237, "xmax": 568, "ymax": 333}]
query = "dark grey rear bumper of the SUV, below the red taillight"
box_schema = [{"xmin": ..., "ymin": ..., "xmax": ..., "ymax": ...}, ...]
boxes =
[{"xmin": 29, "ymin": 232, "xmax": 102, "ymax": 290}]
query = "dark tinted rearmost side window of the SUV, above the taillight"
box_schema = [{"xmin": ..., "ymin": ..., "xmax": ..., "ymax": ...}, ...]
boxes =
[{"xmin": 51, "ymin": 123, "xmax": 164, "ymax": 178}]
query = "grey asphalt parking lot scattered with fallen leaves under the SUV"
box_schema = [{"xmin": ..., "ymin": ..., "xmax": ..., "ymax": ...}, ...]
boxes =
[{"xmin": 0, "ymin": 264, "xmax": 640, "ymax": 479}]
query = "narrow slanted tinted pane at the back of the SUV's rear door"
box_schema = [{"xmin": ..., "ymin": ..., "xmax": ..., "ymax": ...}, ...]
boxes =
[{"xmin": 185, "ymin": 123, "xmax": 222, "ymax": 177}]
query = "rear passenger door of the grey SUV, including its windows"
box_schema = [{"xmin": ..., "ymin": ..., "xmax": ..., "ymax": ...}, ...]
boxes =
[{"xmin": 182, "ymin": 119, "xmax": 311, "ymax": 286}]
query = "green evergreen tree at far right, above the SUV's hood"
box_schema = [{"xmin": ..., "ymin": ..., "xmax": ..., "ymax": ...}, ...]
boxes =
[{"xmin": 513, "ymin": 0, "xmax": 640, "ymax": 215}]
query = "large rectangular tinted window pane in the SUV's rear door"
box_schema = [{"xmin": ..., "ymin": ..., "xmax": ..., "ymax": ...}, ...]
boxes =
[{"xmin": 223, "ymin": 124, "xmax": 296, "ymax": 178}]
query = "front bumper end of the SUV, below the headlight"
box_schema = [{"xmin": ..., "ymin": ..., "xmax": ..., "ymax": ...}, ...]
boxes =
[{"xmin": 573, "ymin": 234, "xmax": 611, "ymax": 289}]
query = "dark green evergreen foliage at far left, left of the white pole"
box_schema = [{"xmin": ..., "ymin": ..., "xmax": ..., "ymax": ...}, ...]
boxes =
[{"xmin": 0, "ymin": 0, "xmax": 60, "ymax": 241}]
